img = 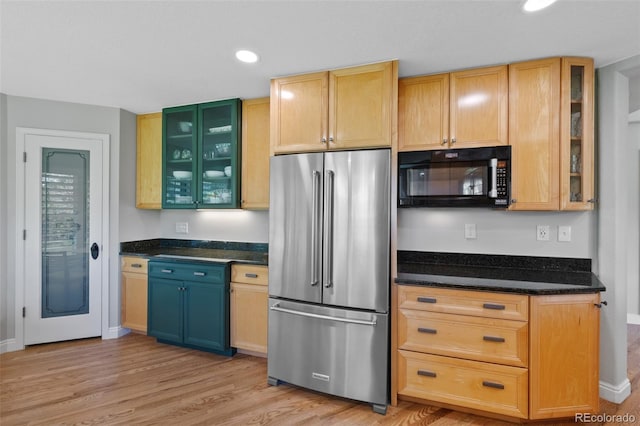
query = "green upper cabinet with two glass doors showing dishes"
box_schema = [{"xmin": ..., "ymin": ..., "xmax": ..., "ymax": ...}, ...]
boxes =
[{"xmin": 162, "ymin": 99, "xmax": 242, "ymax": 209}]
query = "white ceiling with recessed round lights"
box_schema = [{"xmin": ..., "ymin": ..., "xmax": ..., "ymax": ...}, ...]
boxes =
[{"xmin": 0, "ymin": 0, "xmax": 640, "ymax": 113}]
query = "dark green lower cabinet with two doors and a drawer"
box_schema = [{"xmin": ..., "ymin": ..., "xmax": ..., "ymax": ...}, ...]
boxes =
[{"xmin": 147, "ymin": 260, "xmax": 235, "ymax": 356}]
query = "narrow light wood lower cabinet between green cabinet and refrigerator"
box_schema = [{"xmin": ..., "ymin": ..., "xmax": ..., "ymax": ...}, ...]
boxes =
[{"xmin": 231, "ymin": 263, "xmax": 269, "ymax": 356}]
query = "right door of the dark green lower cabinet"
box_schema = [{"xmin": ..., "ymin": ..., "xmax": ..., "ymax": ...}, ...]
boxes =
[{"xmin": 184, "ymin": 282, "xmax": 229, "ymax": 351}]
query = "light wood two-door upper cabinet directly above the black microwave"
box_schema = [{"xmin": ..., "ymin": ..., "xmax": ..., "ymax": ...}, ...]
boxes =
[{"xmin": 398, "ymin": 66, "xmax": 508, "ymax": 151}]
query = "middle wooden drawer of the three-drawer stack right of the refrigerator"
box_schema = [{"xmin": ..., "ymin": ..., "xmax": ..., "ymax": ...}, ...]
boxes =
[{"xmin": 398, "ymin": 309, "xmax": 529, "ymax": 367}]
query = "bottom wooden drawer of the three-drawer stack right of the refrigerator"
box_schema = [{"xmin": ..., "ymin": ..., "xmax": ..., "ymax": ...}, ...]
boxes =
[{"xmin": 398, "ymin": 351, "xmax": 528, "ymax": 418}]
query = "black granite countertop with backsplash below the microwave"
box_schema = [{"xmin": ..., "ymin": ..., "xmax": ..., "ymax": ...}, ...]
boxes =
[{"xmin": 395, "ymin": 251, "xmax": 606, "ymax": 295}]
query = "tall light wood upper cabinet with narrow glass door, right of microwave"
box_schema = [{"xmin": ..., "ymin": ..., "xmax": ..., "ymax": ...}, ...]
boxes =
[{"xmin": 509, "ymin": 58, "xmax": 594, "ymax": 210}]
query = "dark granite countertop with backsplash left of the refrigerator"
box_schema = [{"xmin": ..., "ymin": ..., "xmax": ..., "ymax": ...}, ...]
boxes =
[{"xmin": 120, "ymin": 238, "xmax": 269, "ymax": 265}]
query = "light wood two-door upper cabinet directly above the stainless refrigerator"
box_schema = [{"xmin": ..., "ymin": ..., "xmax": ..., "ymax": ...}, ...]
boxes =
[{"xmin": 270, "ymin": 61, "xmax": 398, "ymax": 155}]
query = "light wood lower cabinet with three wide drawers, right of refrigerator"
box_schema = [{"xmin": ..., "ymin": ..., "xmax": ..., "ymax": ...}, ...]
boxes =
[{"xmin": 396, "ymin": 285, "xmax": 600, "ymax": 419}]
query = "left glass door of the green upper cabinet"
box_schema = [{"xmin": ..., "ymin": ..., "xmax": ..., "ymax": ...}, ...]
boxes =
[{"xmin": 162, "ymin": 105, "xmax": 198, "ymax": 209}]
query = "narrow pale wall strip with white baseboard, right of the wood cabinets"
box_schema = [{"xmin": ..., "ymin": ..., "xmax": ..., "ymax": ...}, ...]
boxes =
[{"xmin": 596, "ymin": 55, "xmax": 640, "ymax": 402}]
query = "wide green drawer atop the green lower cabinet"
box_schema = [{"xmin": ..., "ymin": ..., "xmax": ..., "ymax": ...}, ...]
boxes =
[{"xmin": 149, "ymin": 261, "xmax": 226, "ymax": 284}]
